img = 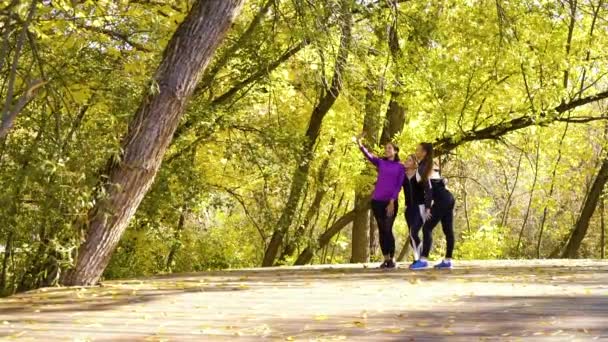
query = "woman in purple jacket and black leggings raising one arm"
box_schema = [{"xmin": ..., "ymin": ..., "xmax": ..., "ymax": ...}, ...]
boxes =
[{"xmin": 357, "ymin": 139, "xmax": 405, "ymax": 268}]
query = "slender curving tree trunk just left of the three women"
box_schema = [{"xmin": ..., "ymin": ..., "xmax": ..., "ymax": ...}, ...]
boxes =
[{"xmin": 262, "ymin": 0, "xmax": 352, "ymax": 267}]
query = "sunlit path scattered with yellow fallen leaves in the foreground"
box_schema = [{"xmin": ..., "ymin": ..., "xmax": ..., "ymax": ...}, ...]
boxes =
[{"xmin": 0, "ymin": 260, "xmax": 608, "ymax": 341}]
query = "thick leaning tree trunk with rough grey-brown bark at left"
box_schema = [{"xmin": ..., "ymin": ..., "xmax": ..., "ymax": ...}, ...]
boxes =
[{"xmin": 62, "ymin": 0, "xmax": 243, "ymax": 285}]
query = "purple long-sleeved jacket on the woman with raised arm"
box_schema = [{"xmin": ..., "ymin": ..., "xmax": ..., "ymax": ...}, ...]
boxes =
[{"xmin": 360, "ymin": 146, "xmax": 405, "ymax": 201}]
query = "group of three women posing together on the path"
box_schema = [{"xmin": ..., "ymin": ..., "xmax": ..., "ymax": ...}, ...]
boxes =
[{"xmin": 357, "ymin": 139, "xmax": 455, "ymax": 270}]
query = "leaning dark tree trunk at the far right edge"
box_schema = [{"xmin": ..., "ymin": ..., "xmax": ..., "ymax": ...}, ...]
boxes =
[{"xmin": 562, "ymin": 157, "xmax": 608, "ymax": 258}]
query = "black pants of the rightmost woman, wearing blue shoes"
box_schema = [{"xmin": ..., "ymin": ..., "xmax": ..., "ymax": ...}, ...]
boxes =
[{"xmin": 422, "ymin": 196, "xmax": 455, "ymax": 258}]
